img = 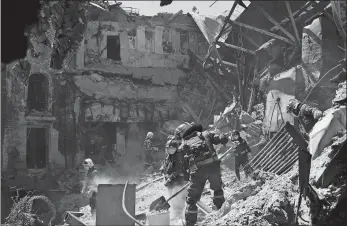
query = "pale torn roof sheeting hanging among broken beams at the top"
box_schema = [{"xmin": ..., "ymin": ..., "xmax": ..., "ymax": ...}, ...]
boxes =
[{"xmin": 188, "ymin": 1, "xmax": 250, "ymax": 44}]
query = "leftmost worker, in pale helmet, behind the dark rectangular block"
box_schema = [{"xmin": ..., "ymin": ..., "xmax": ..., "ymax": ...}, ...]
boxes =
[{"xmin": 82, "ymin": 159, "xmax": 99, "ymax": 217}]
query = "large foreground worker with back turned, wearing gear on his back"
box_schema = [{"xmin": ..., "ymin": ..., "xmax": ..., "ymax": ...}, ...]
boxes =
[{"xmin": 180, "ymin": 125, "xmax": 228, "ymax": 226}]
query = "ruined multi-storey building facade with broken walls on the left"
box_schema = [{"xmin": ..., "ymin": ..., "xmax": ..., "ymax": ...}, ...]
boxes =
[{"xmin": 2, "ymin": 4, "xmax": 231, "ymax": 191}]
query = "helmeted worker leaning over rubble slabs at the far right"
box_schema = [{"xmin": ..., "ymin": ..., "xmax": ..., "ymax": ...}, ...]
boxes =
[{"xmin": 287, "ymin": 99, "xmax": 322, "ymax": 139}]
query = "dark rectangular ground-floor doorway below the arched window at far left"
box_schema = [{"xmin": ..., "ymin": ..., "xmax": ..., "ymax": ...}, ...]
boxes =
[{"xmin": 26, "ymin": 128, "xmax": 47, "ymax": 169}]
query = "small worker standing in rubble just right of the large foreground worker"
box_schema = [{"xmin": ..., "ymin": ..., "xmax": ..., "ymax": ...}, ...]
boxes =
[{"xmin": 231, "ymin": 130, "xmax": 251, "ymax": 180}]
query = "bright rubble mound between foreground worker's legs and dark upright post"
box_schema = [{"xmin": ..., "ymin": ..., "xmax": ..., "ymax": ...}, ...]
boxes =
[{"xmin": 202, "ymin": 171, "xmax": 298, "ymax": 225}]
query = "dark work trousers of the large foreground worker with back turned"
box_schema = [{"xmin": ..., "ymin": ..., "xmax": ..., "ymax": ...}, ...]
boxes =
[{"xmin": 185, "ymin": 161, "xmax": 225, "ymax": 226}]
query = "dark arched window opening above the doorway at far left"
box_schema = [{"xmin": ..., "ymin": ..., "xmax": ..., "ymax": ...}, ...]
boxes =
[{"xmin": 28, "ymin": 74, "xmax": 49, "ymax": 111}]
